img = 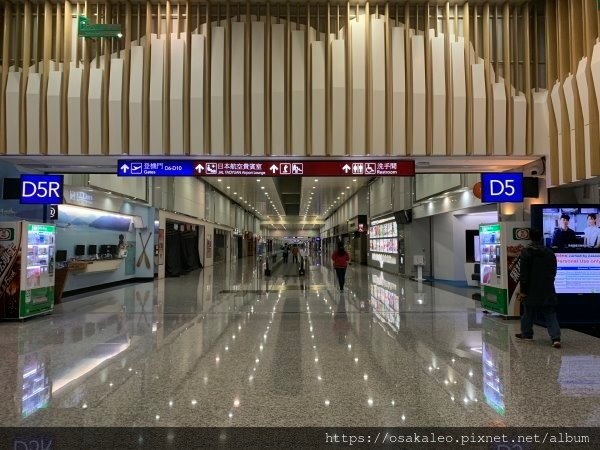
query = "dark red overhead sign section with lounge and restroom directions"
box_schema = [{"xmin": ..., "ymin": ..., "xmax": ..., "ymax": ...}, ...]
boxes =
[{"xmin": 194, "ymin": 159, "xmax": 415, "ymax": 177}]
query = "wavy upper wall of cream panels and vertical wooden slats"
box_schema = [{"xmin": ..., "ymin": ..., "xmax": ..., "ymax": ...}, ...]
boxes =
[{"xmin": 0, "ymin": 0, "xmax": 584, "ymax": 185}]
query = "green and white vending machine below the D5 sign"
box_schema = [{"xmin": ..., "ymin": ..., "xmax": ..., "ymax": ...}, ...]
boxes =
[{"xmin": 479, "ymin": 222, "xmax": 530, "ymax": 317}]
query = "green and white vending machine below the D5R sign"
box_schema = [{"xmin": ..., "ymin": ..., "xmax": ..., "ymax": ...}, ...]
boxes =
[{"xmin": 0, "ymin": 221, "xmax": 56, "ymax": 319}]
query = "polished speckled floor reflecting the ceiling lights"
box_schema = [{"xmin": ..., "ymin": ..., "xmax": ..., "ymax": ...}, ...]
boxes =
[{"xmin": 0, "ymin": 256, "xmax": 600, "ymax": 427}]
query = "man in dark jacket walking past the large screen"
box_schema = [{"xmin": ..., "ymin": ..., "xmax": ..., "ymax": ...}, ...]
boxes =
[{"xmin": 515, "ymin": 229, "xmax": 561, "ymax": 348}]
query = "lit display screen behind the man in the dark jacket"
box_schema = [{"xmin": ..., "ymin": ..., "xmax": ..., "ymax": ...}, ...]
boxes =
[{"xmin": 531, "ymin": 205, "xmax": 600, "ymax": 294}]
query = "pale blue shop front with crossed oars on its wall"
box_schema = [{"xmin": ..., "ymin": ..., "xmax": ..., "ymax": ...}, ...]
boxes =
[{"xmin": 53, "ymin": 186, "xmax": 154, "ymax": 300}]
